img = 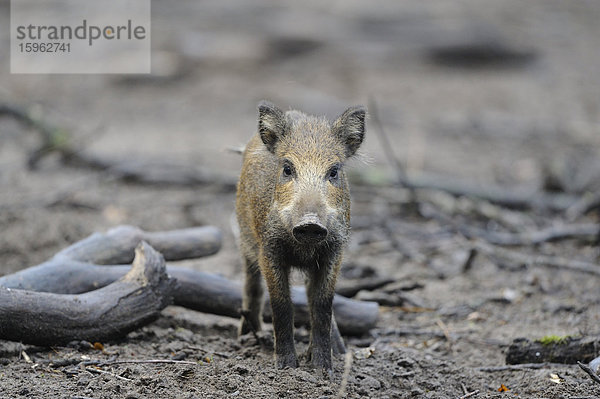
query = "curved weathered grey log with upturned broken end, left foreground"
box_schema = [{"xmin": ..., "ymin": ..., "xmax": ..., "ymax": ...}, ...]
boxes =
[{"xmin": 0, "ymin": 242, "xmax": 176, "ymax": 345}]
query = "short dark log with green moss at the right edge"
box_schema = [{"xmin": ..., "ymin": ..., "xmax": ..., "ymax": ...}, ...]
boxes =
[{"xmin": 506, "ymin": 337, "xmax": 600, "ymax": 364}]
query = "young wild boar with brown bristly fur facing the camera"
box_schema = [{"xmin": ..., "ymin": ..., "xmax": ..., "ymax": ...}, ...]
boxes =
[{"xmin": 236, "ymin": 101, "xmax": 365, "ymax": 374}]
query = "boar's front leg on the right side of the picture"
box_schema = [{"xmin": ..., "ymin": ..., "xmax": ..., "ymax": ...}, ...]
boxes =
[{"xmin": 306, "ymin": 261, "xmax": 340, "ymax": 376}]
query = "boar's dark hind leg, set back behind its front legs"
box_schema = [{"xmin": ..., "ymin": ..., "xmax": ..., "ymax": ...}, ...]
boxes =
[{"xmin": 238, "ymin": 259, "xmax": 263, "ymax": 335}]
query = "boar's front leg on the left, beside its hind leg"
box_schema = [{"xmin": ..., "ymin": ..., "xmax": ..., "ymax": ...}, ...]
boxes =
[{"xmin": 261, "ymin": 261, "xmax": 298, "ymax": 368}]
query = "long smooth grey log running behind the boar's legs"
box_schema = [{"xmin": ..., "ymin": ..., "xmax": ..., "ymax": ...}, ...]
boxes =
[{"xmin": 0, "ymin": 262, "xmax": 379, "ymax": 335}]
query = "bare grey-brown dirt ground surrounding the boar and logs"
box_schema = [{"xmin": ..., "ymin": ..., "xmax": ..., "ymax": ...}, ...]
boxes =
[{"xmin": 0, "ymin": 0, "xmax": 600, "ymax": 399}]
